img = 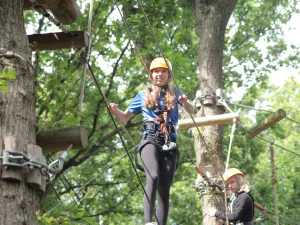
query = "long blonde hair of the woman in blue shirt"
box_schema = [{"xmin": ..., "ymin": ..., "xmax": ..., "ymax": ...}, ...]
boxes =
[{"xmin": 145, "ymin": 83, "xmax": 175, "ymax": 110}]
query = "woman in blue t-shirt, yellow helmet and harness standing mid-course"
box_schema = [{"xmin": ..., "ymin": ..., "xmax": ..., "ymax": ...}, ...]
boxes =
[{"xmin": 109, "ymin": 57, "xmax": 194, "ymax": 225}]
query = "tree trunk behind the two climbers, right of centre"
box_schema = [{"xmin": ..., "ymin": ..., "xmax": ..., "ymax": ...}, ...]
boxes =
[{"xmin": 190, "ymin": 0, "xmax": 236, "ymax": 225}]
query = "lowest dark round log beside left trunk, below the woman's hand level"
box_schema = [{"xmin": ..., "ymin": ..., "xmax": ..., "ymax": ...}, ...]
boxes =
[{"xmin": 36, "ymin": 126, "xmax": 88, "ymax": 152}]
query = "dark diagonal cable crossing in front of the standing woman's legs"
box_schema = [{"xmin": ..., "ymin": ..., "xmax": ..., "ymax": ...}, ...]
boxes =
[{"xmin": 88, "ymin": 63, "xmax": 160, "ymax": 225}]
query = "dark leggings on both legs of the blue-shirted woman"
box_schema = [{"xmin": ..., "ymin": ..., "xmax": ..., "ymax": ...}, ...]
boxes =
[{"xmin": 141, "ymin": 143, "xmax": 177, "ymax": 225}]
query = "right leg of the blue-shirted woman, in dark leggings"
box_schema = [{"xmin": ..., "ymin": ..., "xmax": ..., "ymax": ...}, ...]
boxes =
[{"xmin": 156, "ymin": 153, "xmax": 177, "ymax": 225}]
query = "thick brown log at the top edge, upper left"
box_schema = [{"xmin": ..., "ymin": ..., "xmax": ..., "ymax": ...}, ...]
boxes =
[{"xmin": 23, "ymin": 0, "xmax": 80, "ymax": 25}]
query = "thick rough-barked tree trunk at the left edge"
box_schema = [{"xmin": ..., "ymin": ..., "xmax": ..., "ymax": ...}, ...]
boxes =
[{"xmin": 0, "ymin": 0, "xmax": 40, "ymax": 225}]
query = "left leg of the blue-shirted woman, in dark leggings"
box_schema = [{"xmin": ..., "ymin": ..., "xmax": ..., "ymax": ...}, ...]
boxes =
[{"xmin": 141, "ymin": 143, "xmax": 159, "ymax": 223}]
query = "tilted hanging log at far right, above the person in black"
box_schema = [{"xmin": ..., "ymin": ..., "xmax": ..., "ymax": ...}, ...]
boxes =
[{"xmin": 247, "ymin": 109, "xmax": 286, "ymax": 139}]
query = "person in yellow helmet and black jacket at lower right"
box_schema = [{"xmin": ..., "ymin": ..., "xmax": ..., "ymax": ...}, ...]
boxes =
[{"xmin": 208, "ymin": 168, "xmax": 254, "ymax": 225}]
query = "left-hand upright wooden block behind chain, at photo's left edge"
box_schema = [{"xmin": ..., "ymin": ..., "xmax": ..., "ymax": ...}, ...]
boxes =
[{"xmin": 2, "ymin": 136, "xmax": 22, "ymax": 181}]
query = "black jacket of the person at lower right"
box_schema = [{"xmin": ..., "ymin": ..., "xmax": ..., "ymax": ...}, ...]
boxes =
[{"xmin": 215, "ymin": 192, "xmax": 254, "ymax": 225}]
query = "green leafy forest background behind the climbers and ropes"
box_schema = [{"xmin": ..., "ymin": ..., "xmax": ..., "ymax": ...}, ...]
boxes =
[{"xmin": 24, "ymin": 0, "xmax": 300, "ymax": 225}]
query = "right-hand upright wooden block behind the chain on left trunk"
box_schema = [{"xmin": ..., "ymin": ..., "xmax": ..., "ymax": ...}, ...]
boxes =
[{"xmin": 26, "ymin": 144, "xmax": 43, "ymax": 190}]
